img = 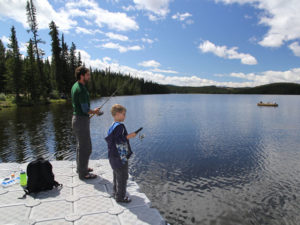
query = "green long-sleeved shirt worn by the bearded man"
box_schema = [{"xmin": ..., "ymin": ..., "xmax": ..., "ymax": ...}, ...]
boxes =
[{"xmin": 71, "ymin": 81, "xmax": 90, "ymax": 116}]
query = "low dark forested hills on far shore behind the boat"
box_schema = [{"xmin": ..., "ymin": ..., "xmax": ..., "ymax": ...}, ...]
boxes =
[{"xmin": 166, "ymin": 83, "xmax": 300, "ymax": 95}]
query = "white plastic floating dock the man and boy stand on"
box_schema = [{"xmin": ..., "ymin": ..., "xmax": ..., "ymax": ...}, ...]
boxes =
[{"xmin": 0, "ymin": 159, "xmax": 166, "ymax": 225}]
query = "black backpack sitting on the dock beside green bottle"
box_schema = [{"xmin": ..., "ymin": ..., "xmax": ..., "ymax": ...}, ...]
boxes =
[{"xmin": 24, "ymin": 158, "xmax": 62, "ymax": 194}]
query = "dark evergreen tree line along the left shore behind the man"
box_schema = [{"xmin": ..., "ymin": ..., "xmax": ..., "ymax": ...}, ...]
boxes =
[{"xmin": 0, "ymin": 0, "xmax": 168, "ymax": 105}]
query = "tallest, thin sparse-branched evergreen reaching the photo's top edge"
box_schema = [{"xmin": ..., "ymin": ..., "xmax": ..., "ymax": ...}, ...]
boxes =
[{"xmin": 26, "ymin": 0, "xmax": 48, "ymax": 99}]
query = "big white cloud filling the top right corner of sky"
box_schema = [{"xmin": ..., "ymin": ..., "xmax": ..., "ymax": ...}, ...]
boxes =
[{"xmin": 215, "ymin": 0, "xmax": 300, "ymax": 47}]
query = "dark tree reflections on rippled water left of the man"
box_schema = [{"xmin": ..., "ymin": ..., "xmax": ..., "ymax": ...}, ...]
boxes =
[{"xmin": 0, "ymin": 104, "xmax": 75, "ymax": 162}]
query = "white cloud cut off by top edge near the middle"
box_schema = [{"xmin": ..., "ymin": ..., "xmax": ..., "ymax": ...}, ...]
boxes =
[{"xmin": 133, "ymin": 0, "xmax": 171, "ymax": 20}]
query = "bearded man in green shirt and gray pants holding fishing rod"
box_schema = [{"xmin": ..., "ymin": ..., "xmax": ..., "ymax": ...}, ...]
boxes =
[{"xmin": 71, "ymin": 66, "xmax": 103, "ymax": 179}]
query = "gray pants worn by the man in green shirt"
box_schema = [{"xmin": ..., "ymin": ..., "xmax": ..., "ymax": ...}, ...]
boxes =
[{"xmin": 72, "ymin": 115, "xmax": 92, "ymax": 179}]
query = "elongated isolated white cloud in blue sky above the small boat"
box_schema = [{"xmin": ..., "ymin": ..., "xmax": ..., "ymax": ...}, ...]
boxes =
[{"xmin": 198, "ymin": 41, "xmax": 257, "ymax": 65}]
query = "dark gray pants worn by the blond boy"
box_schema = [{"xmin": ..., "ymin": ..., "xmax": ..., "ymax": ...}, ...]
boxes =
[{"xmin": 113, "ymin": 162, "xmax": 128, "ymax": 201}]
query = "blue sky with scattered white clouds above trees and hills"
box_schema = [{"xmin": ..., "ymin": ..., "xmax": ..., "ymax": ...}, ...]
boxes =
[{"xmin": 0, "ymin": 0, "xmax": 300, "ymax": 87}]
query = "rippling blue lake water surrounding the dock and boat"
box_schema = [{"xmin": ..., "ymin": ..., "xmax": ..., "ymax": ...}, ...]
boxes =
[{"xmin": 0, "ymin": 94, "xmax": 300, "ymax": 225}]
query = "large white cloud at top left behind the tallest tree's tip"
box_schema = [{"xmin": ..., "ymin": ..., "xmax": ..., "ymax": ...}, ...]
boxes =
[{"xmin": 0, "ymin": 0, "xmax": 139, "ymax": 32}]
